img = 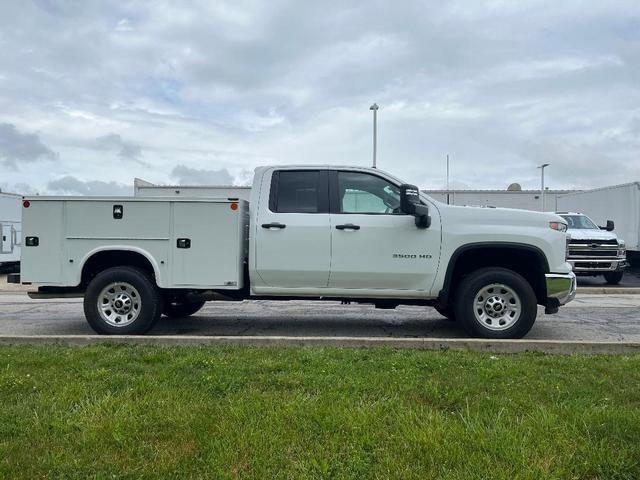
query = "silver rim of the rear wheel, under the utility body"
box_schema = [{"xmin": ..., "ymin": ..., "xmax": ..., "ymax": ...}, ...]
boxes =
[{"xmin": 98, "ymin": 282, "xmax": 142, "ymax": 327}]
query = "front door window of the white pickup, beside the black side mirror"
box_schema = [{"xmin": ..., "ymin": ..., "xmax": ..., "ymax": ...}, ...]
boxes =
[{"xmin": 338, "ymin": 172, "xmax": 401, "ymax": 214}]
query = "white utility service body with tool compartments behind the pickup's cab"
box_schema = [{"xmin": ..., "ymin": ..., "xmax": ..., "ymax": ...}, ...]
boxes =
[{"xmin": 21, "ymin": 197, "xmax": 249, "ymax": 289}]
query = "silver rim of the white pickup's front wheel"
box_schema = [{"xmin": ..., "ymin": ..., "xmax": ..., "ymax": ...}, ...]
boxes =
[{"xmin": 473, "ymin": 283, "xmax": 522, "ymax": 331}]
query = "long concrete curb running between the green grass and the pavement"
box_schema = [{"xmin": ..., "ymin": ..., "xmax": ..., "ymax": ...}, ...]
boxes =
[{"xmin": 0, "ymin": 335, "xmax": 640, "ymax": 355}]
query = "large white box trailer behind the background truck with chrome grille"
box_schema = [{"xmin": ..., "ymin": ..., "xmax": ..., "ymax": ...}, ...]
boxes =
[{"xmin": 558, "ymin": 182, "xmax": 640, "ymax": 265}]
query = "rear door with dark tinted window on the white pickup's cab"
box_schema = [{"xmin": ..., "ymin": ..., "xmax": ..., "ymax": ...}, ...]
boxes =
[{"xmin": 254, "ymin": 169, "xmax": 331, "ymax": 289}]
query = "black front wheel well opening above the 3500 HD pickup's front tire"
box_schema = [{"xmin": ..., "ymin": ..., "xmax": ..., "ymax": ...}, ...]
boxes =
[{"xmin": 439, "ymin": 245, "xmax": 549, "ymax": 305}]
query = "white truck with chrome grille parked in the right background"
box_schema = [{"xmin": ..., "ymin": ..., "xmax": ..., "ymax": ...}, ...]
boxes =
[{"xmin": 558, "ymin": 212, "xmax": 627, "ymax": 285}]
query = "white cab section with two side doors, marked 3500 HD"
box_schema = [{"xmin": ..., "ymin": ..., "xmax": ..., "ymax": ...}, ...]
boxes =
[{"xmin": 249, "ymin": 167, "xmax": 441, "ymax": 299}]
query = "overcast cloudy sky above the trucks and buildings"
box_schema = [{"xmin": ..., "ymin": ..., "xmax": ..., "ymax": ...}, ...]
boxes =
[{"xmin": 0, "ymin": 0, "xmax": 640, "ymax": 194}]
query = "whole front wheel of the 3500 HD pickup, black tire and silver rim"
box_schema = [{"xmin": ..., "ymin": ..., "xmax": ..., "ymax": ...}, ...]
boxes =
[{"xmin": 454, "ymin": 268, "xmax": 538, "ymax": 339}]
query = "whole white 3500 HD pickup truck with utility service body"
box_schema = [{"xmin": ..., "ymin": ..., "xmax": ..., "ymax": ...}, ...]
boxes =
[{"xmin": 12, "ymin": 166, "xmax": 576, "ymax": 338}]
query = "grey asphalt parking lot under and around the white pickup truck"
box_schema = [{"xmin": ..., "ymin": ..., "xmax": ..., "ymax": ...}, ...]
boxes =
[{"xmin": 0, "ymin": 292, "xmax": 640, "ymax": 342}]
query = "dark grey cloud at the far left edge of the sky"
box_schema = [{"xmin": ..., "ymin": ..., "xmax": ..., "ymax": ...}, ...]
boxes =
[{"xmin": 0, "ymin": 123, "xmax": 58, "ymax": 169}]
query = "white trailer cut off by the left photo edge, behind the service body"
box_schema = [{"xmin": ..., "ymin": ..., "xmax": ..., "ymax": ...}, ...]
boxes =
[{"xmin": 0, "ymin": 192, "xmax": 22, "ymax": 269}]
